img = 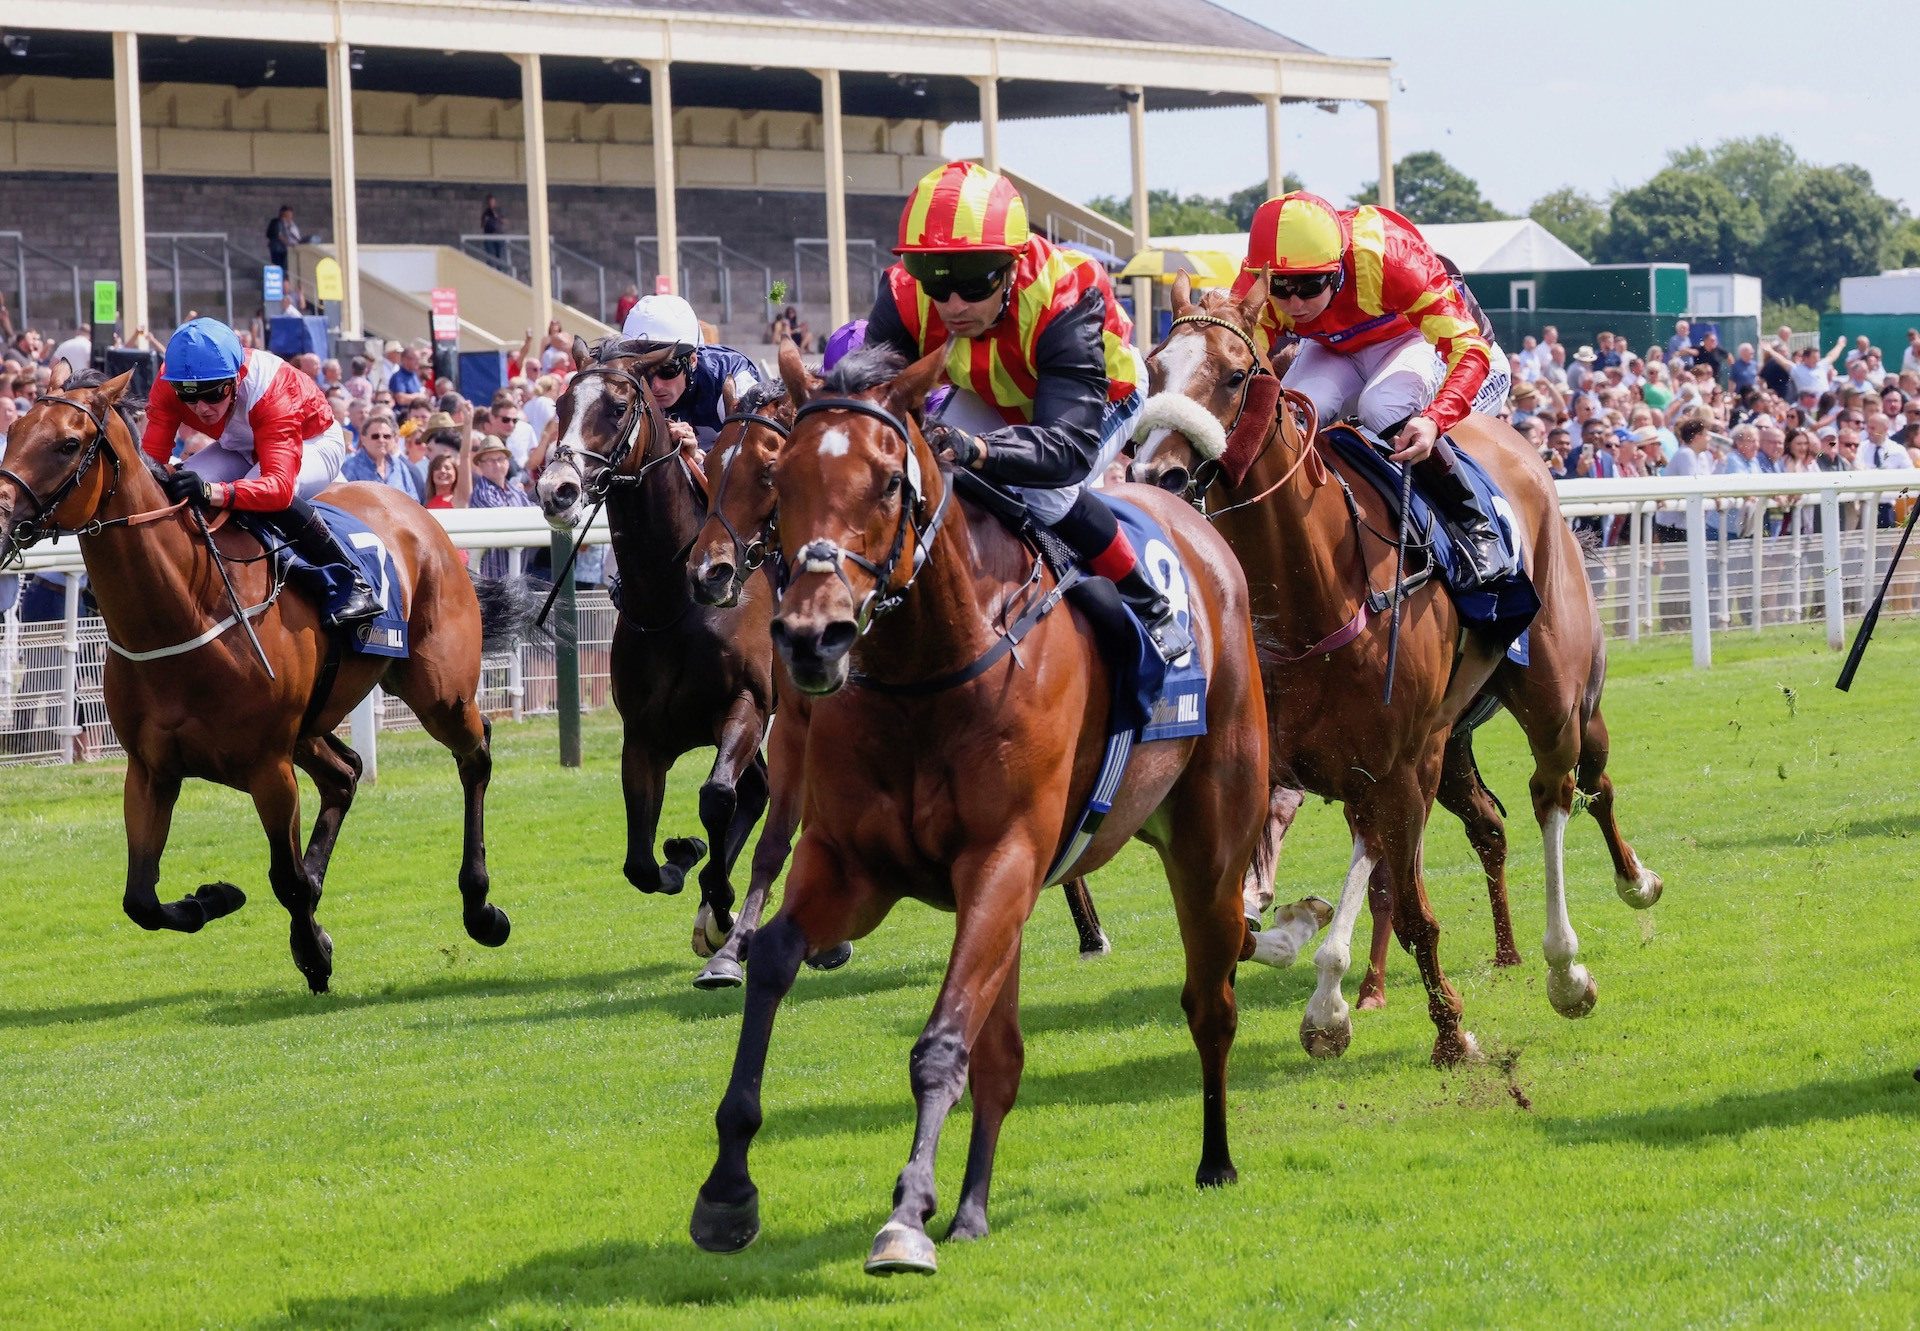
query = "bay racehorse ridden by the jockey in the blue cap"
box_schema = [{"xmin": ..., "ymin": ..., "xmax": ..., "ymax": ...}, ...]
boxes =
[{"xmin": 0, "ymin": 363, "xmax": 532, "ymax": 993}]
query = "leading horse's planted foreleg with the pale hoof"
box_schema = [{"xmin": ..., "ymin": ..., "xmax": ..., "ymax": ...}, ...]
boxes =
[{"xmin": 866, "ymin": 843, "xmax": 1041, "ymax": 1275}]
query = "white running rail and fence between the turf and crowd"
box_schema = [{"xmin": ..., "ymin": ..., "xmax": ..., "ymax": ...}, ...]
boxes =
[{"xmin": 0, "ymin": 471, "xmax": 1920, "ymax": 762}]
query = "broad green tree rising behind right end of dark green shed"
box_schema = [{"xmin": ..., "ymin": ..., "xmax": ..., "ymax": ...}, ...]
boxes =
[{"xmin": 1594, "ymin": 167, "xmax": 1761, "ymax": 273}]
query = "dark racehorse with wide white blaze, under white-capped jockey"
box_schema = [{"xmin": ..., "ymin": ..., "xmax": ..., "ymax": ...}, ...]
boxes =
[{"xmin": 540, "ymin": 338, "xmax": 774, "ymax": 971}]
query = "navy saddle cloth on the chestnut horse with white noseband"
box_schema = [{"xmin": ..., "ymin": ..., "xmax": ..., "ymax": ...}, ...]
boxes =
[{"xmin": 1319, "ymin": 421, "xmax": 1540, "ymax": 666}]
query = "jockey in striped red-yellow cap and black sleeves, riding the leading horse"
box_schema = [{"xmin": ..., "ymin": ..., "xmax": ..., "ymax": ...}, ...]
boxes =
[{"xmin": 866, "ymin": 161, "xmax": 1192, "ymax": 661}]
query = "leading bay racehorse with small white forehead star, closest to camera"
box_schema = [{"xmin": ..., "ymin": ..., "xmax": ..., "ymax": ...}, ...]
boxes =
[{"xmin": 691, "ymin": 350, "xmax": 1267, "ymax": 1273}]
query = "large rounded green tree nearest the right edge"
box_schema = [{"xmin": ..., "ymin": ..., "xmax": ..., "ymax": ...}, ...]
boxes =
[{"xmin": 1761, "ymin": 167, "xmax": 1897, "ymax": 305}]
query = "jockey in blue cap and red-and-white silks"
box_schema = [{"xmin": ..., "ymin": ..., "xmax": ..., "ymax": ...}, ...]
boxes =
[{"xmin": 140, "ymin": 319, "xmax": 380, "ymax": 628}]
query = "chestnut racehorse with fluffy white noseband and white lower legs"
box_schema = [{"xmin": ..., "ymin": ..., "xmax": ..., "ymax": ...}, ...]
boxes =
[{"xmin": 1135, "ymin": 282, "xmax": 1663, "ymax": 1064}]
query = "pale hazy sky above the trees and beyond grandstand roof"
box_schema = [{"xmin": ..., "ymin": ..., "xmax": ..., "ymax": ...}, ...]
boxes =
[{"xmin": 947, "ymin": 0, "xmax": 1920, "ymax": 213}]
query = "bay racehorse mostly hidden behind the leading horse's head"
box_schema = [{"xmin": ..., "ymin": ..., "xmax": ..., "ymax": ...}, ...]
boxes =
[{"xmin": 687, "ymin": 342, "xmax": 1110, "ymax": 987}]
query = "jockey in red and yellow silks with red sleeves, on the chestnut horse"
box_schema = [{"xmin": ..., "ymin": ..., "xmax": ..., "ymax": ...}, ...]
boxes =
[{"xmin": 1233, "ymin": 190, "xmax": 1507, "ymax": 582}]
